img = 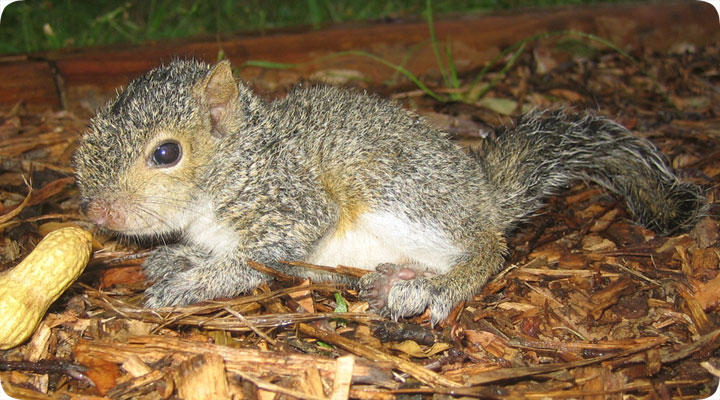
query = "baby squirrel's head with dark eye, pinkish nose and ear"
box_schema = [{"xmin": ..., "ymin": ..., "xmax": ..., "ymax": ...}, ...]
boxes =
[{"xmin": 73, "ymin": 60, "xmax": 249, "ymax": 236}]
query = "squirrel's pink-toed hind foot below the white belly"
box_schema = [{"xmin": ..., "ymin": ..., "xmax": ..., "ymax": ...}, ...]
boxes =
[{"xmin": 359, "ymin": 264, "xmax": 455, "ymax": 324}]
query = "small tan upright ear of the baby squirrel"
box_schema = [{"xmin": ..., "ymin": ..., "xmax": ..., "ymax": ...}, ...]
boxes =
[{"xmin": 195, "ymin": 60, "xmax": 238, "ymax": 137}]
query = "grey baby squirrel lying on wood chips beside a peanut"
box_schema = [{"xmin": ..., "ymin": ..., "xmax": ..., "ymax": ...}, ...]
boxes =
[{"xmin": 73, "ymin": 60, "xmax": 706, "ymax": 323}]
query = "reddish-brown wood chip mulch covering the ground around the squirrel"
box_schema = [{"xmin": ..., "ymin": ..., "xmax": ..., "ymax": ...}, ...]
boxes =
[{"xmin": 0, "ymin": 39, "xmax": 720, "ymax": 399}]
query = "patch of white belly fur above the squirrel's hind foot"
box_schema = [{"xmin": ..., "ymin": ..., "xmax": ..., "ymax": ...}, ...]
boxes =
[{"xmin": 306, "ymin": 211, "xmax": 462, "ymax": 273}]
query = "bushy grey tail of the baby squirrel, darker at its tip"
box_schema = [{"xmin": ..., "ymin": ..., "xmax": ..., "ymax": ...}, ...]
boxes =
[{"xmin": 478, "ymin": 112, "xmax": 707, "ymax": 234}]
